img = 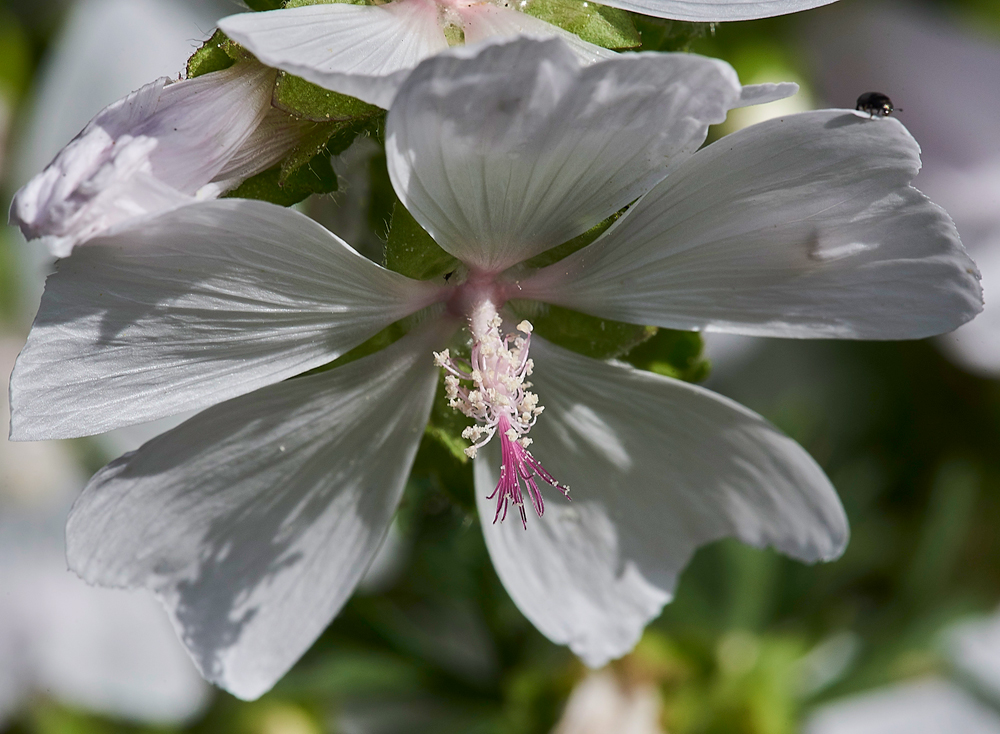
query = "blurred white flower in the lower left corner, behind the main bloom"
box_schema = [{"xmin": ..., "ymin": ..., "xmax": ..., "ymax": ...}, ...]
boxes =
[{"xmin": 0, "ymin": 336, "xmax": 209, "ymax": 729}]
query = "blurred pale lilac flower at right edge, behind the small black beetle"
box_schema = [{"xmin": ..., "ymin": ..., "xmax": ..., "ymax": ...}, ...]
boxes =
[{"xmin": 810, "ymin": 4, "xmax": 1000, "ymax": 377}]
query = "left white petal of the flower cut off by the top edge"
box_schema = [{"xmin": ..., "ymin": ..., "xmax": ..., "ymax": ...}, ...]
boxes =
[{"xmin": 225, "ymin": 0, "xmax": 448, "ymax": 108}]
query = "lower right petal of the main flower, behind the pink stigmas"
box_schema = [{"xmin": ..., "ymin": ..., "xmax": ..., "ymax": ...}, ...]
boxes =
[{"xmin": 476, "ymin": 337, "xmax": 847, "ymax": 667}]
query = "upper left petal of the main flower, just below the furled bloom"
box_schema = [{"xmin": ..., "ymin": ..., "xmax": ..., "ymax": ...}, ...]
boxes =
[{"xmin": 11, "ymin": 199, "xmax": 436, "ymax": 440}]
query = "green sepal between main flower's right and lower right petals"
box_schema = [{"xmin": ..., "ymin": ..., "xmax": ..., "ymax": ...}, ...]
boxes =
[{"xmin": 508, "ymin": 301, "xmax": 656, "ymax": 359}]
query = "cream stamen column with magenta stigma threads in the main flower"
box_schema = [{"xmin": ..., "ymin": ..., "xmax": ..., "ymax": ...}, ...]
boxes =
[{"xmin": 434, "ymin": 301, "xmax": 569, "ymax": 528}]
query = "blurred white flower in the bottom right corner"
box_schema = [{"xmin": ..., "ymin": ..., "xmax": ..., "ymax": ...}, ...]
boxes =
[{"xmin": 804, "ymin": 615, "xmax": 1000, "ymax": 734}]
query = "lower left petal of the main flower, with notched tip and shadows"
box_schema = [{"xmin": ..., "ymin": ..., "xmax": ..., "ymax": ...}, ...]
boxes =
[{"xmin": 66, "ymin": 322, "xmax": 447, "ymax": 699}]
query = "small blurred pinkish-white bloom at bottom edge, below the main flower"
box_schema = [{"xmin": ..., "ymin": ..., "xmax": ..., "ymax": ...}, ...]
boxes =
[{"xmin": 552, "ymin": 670, "xmax": 664, "ymax": 734}]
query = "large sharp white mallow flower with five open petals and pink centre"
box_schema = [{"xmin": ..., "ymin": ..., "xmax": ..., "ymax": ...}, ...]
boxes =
[{"xmin": 5, "ymin": 39, "xmax": 981, "ymax": 698}]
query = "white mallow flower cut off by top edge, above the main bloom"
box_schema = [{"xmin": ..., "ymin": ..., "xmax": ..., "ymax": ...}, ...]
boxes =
[{"xmin": 219, "ymin": 0, "xmax": 835, "ymax": 109}]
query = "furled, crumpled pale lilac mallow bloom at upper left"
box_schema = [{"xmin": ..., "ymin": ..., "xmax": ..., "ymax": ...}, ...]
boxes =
[{"xmin": 10, "ymin": 60, "xmax": 303, "ymax": 257}]
